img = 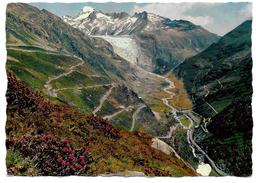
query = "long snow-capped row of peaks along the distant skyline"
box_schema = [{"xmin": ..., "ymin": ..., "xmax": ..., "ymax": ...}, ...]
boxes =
[{"xmin": 63, "ymin": 6, "xmax": 208, "ymax": 35}]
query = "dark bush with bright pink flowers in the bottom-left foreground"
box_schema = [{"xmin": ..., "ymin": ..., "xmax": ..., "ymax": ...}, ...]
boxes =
[{"xmin": 7, "ymin": 135, "xmax": 93, "ymax": 175}]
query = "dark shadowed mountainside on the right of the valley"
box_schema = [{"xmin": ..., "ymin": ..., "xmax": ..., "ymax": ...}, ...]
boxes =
[{"xmin": 174, "ymin": 20, "xmax": 253, "ymax": 176}]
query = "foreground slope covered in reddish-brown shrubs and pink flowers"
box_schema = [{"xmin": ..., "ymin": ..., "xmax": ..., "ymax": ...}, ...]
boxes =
[{"xmin": 6, "ymin": 73, "xmax": 196, "ymax": 176}]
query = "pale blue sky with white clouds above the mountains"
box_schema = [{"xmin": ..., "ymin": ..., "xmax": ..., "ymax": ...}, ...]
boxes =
[{"xmin": 30, "ymin": 2, "xmax": 252, "ymax": 36}]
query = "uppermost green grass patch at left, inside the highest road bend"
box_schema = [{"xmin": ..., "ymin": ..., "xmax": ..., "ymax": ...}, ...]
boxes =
[{"xmin": 6, "ymin": 49, "xmax": 77, "ymax": 91}]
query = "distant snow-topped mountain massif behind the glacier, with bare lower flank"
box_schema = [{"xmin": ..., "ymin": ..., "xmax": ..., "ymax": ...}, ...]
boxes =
[{"xmin": 62, "ymin": 7, "xmax": 219, "ymax": 74}]
